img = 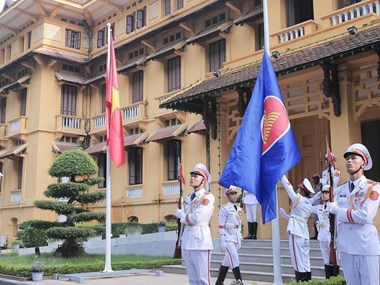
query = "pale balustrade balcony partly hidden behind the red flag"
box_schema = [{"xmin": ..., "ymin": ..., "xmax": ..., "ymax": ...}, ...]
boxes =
[{"xmin": 91, "ymin": 101, "xmax": 147, "ymax": 134}]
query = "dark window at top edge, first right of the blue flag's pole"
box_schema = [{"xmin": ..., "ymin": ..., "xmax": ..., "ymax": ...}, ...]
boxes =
[{"xmin": 286, "ymin": 0, "xmax": 314, "ymax": 27}]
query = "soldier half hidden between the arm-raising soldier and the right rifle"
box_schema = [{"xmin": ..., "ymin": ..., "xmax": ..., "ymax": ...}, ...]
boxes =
[{"xmin": 311, "ymin": 184, "xmax": 331, "ymax": 278}]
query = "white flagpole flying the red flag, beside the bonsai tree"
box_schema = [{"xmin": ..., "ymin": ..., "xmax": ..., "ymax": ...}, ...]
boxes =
[{"xmin": 103, "ymin": 23, "xmax": 113, "ymax": 272}]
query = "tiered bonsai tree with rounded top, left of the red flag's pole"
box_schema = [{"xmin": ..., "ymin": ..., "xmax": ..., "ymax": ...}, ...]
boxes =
[{"xmin": 29, "ymin": 150, "xmax": 106, "ymax": 257}]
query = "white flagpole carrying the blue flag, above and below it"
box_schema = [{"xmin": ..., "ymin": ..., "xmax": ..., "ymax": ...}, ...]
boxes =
[{"xmin": 263, "ymin": 0, "xmax": 282, "ymax": 285}]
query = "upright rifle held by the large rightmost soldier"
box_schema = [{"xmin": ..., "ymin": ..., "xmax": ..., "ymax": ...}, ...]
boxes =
[{"xmin": 325, "ymin": 137, "xmax": 339, "ymax": 278}]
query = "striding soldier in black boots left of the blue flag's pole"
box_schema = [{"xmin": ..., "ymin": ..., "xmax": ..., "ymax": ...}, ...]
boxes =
[{"xmin": 215, "ymin": 185, "xmax": 243, "ymax": 285}]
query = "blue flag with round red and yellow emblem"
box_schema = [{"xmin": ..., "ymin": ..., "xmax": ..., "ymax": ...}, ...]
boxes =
[{"xmin": 219, "ymin": 52, "xmax": 300, "ymax": 224}]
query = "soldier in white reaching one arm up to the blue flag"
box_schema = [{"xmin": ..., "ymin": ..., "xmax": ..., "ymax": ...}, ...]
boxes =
[{"xmin": 280, "ymin": 175, "xmax": 321, "ymax": 282}]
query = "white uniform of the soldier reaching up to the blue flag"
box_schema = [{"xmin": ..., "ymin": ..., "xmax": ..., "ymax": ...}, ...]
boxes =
[{"xmin": 281, "ymin": 176, "xmax": 314, "ymax": 272}]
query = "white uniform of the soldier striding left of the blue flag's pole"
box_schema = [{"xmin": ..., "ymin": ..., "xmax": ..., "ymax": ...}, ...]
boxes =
[{"xmin": 219, "ymin": 202, "xmax": 242, "ymax": 269}]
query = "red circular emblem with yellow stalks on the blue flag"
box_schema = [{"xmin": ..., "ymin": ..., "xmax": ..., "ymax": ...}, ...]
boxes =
[{"xmin": 261, "ymin": 95, "xmax": 290, "ymax": 155}]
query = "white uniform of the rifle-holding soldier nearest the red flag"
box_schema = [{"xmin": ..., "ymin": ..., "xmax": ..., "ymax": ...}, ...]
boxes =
[{"xmin": 181, "ymin": 189, "xmax": 215, "ymax": 285}]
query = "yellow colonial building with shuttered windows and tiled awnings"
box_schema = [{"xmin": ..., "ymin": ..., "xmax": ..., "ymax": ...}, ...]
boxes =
[{"xmin": 0, "ymin": 0, "xmax": 380, "ymax": 243}]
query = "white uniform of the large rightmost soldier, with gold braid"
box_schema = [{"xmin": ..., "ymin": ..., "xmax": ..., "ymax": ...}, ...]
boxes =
[{"xmin": 335, "ymin": 175, "xmax": 380, "ymax": 285}]
